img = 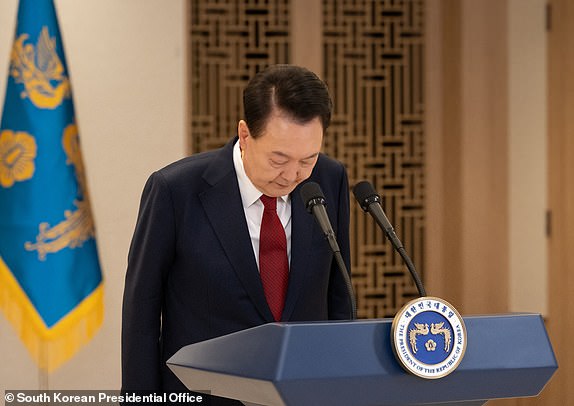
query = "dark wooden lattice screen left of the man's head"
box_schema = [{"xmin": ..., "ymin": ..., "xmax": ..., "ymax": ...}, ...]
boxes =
[{"xmin": 190, "ymin": 0, "xmax": 290, "ymax": 152}]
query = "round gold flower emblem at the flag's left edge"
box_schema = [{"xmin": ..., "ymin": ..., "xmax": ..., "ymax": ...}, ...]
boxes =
[{"xmin": 0, "ymin": 130, "xmax": 36, "ymax": 188}]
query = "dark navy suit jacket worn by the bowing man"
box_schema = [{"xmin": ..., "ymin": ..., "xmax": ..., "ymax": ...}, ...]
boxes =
[{"xmin": 122, "ymin": 138, "xmax": 351, "ymax": 398}]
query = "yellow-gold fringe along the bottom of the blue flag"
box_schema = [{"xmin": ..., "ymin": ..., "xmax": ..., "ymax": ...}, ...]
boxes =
[{"xmin": 0, "ymin": 257, "xmax": 104, "ymax": 372}]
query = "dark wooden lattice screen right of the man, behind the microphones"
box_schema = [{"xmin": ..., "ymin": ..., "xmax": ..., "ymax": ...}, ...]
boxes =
[{"xmin": 323, "ymin": 0, "xmax": 425, "ymax": 318}]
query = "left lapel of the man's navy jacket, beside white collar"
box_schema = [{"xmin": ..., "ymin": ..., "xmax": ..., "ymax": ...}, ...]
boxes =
[{"xmin": 199, "ymin": 140, "xmax": 273, "ymax": 322}]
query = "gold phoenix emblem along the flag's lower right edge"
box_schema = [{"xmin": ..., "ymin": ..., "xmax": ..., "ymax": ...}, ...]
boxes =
[{"xmin": 25, "ymin": 124, "xmax": 95, "ymax": 261}]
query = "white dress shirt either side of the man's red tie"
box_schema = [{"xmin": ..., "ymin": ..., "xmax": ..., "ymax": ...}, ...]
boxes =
[{"xmin": 233, "ymin": 141, "xmax": 291, "ymax": 268}]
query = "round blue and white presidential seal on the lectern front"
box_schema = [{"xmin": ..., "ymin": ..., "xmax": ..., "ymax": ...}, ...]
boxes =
[{"xmin": 391, "ymin": 297, "xmax": 467, "ymax": 379}]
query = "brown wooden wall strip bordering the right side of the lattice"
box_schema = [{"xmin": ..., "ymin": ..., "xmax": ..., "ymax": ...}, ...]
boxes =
[{"xmin": 425, "ymin": 0, "xmax": 464, "ymax": 304}]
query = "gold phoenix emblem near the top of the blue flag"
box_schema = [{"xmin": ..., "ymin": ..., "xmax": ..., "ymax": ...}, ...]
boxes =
[{"xmin": 10, "ymin": 27, "xmax": 71, "ymax": 109}]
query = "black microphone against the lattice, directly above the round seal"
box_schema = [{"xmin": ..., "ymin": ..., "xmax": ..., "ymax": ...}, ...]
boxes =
[{"xmin": 353, "ymin": 181, "xmax": 426, "ymax": 297}]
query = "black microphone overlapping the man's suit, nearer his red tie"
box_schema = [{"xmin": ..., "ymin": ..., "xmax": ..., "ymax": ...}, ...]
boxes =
[{"xmin": 300, "ymin": 182, "xmax": 357, "ymax": 320}]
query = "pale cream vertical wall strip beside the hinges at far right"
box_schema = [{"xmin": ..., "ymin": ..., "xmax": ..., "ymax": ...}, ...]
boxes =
[{"xmin": 508, "ymin": 0, "xmax": 548, "ymax": 315}]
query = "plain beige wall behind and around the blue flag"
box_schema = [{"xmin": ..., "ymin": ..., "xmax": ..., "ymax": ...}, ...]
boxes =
[{"xmin": 0, "ymin": 0, "xmax": 186, "ymax": 391}]
